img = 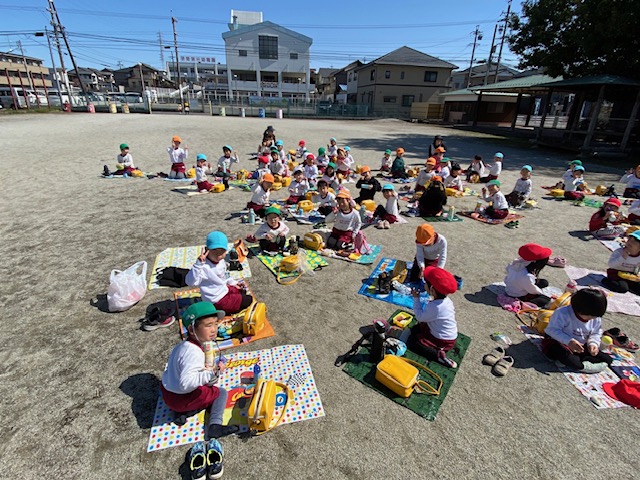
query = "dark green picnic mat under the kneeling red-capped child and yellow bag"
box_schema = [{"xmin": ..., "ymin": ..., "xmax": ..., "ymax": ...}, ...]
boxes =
[{"xmin": 342, "ymin": 310, "xmax": 471, "ymax": 421}]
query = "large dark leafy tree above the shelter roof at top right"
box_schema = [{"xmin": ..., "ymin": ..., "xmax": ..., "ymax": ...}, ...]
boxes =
[{"xmin": 508, "ymin": 0, "xmax": 640, "ymax": 79}]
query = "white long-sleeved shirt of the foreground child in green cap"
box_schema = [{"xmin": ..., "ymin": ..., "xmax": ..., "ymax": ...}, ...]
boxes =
[{"xmin": 162, "ymin": 341, "xmax": 217, "ymax": 394}]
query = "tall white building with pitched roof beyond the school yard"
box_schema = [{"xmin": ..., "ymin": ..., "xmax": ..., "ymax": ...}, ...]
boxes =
[{"xmin": 222, "ymin": 10, "xmax": 313, "ymax": 100}]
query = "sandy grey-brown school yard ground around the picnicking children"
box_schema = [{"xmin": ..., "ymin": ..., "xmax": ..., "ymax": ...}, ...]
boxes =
[{"xmin": 0, "ymin": 114, "xmax": 640, "ymax": 479}]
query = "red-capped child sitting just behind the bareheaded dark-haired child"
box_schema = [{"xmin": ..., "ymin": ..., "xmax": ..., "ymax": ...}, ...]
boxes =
[{"xmin": 504, "ymin": 243, "xmax": 552, "ymax": 308}]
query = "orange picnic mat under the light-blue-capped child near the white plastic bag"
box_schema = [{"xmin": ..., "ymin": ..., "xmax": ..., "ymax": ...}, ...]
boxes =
[{"xmin": 173, "ymin": 287, "xmax": 276, "ymax": 350}]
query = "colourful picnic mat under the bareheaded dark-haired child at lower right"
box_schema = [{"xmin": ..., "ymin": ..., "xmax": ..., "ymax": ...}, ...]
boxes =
[{"xmin": 518, "ymin": 325, "xmax": 635, "ymax": 409}]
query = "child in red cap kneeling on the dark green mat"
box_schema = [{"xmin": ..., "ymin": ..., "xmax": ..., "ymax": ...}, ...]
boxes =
[{"xmin": 407, "ymin": 267, "xmax": 458, "ymax": 368}]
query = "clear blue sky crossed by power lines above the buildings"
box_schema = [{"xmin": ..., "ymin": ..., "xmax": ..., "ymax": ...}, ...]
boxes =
[{"xmin": 0, "ymin": 0, "xmax": 521, "ymax": 73}]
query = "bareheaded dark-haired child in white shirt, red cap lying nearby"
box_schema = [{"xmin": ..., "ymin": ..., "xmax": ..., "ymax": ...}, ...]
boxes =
[{"xmin": 542, "ymin": 288, "xmax": 613, "ymax": 373}]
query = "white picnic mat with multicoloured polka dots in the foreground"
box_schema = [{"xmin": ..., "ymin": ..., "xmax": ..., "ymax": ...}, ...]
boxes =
[{"xmin": 147, "ymin": 345, "xmax": 325, "ymax": 452}]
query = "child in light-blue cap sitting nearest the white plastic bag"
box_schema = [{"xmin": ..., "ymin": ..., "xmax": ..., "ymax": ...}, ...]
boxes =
[{"xmin": 184, "ymin": 232, "xmax": 253, "ymax": 313}]
